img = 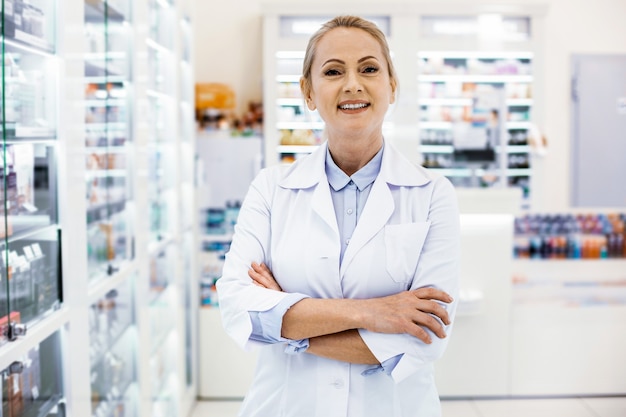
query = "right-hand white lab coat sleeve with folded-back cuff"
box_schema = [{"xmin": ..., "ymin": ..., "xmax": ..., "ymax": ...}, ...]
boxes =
[{"xmin": 359, "ymin": 177, "xmax": 460, "ymax": 383}]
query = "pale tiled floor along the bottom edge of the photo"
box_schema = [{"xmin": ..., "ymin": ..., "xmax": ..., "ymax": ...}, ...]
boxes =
[{"xmin": 189, "ymin": 397, "xmax": 626, "ymax": 417}]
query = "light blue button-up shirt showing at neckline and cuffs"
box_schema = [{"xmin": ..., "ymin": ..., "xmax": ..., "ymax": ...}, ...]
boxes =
[{"xmin": 250, "ymin": 147, "xmax": 401, "ymax": 375}]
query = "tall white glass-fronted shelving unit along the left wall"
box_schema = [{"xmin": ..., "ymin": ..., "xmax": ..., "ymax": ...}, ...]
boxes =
[{"xmin": 0, "ymin": 0, "xmax": 198, "ymax": 417}]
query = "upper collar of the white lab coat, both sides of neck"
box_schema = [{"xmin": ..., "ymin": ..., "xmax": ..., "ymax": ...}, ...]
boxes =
[{"xmin": 279, "ymin": 141, "xmax": 431, "ymax": 189}]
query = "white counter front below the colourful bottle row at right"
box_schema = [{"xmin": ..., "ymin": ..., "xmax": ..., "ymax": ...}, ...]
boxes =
[{"xmin": 511, "ymin": 259, "xmax": 626, "ymax": 395}]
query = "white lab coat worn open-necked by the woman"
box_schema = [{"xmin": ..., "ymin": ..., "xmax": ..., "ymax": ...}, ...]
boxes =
[{"xmin": 216, "ymin": 143, "xmax": 459, "ymax": 417}]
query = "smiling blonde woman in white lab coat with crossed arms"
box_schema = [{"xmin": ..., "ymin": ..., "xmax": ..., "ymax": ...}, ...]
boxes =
[{"xmin": 217, "ymin": 16, "xmax": 459, "ymax": 417}]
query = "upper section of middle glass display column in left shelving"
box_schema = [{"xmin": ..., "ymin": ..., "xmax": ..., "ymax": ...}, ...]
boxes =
[{"xmin": 84, "ymin": 0, "xmax": 134, "ymax": 282}]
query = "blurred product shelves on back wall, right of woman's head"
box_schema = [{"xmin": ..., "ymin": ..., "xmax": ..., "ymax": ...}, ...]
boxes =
[{"xmin": 417, "ymin": 51, "xmax": 534, "ymax": 200}]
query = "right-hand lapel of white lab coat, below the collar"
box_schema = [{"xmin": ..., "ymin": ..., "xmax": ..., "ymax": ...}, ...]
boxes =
[{"xmin": 340, "ymin": 175, "xmax": 395, "ymax": 278}]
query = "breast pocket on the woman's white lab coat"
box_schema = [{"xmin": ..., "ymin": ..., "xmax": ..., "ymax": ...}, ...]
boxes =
[{"xmin": 385, "ymin": 222, "xmax": 430, "ymax": 283}]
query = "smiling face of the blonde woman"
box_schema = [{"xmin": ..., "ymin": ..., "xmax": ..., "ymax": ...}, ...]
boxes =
[{"xmin": 302, "ymin": 27, "xmax": 395, "ymax": 146}]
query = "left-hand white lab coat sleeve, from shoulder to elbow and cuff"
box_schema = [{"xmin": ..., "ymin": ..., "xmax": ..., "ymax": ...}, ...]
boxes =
[{"xmin": 216, "ymin": 169, "xmax": 298, "ymax": 350}]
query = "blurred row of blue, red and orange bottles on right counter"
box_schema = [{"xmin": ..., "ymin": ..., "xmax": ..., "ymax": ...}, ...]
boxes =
[{"xmin": 513, "ymin": 213, "xmax": 626, "ymax": 259}]
